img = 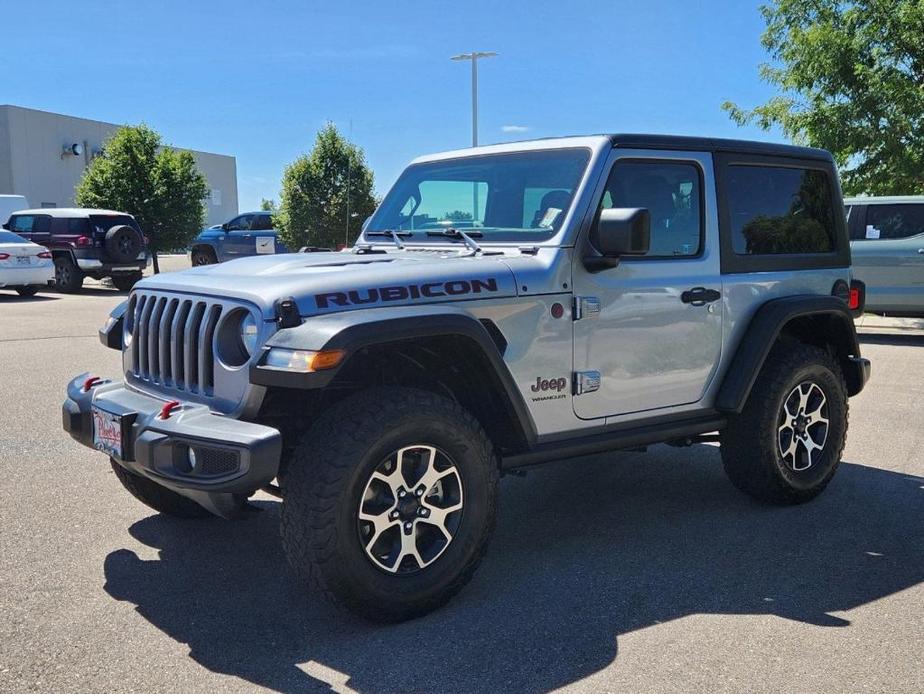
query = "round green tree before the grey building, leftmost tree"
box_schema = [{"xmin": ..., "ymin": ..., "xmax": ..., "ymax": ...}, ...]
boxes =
[{"xmin": 74, "ymin": 124, "xmax": 208, "ymax": 272}]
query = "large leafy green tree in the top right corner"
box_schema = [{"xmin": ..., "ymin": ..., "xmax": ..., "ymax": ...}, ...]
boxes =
[{"xmin": 723, "ymin": 0, "xmax": 924, "ymax": 195}]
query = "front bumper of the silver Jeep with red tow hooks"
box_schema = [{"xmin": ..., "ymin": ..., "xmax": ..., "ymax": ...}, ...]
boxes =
[{"xmin": 62, "ymin": 374, "xmax": 282, "ymax": 516}]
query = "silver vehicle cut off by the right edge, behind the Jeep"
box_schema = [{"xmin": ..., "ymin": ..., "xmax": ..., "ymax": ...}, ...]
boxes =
[{"xmin": 844, "ymin": 195, "xmax": 924, "ymax": 316}]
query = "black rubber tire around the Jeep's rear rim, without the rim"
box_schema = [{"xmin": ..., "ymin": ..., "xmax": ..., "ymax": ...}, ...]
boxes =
[{"xmin": 721, "ymin": 342, "xmax": 848, "ymax": 505}]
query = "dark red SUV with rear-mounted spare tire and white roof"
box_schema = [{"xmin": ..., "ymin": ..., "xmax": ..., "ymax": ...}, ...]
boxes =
[{"xmin": 3, "ymin": 208, "xmax": 148, "ymax": 294}]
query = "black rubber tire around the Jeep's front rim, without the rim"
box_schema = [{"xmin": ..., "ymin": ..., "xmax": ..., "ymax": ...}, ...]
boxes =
[{"xmin": 281, "ymin": 388, "xmax": 498, "ymax": 622}]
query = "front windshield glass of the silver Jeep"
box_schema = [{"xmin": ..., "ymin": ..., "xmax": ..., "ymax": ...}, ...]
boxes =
[{"xmin": 366, "ymin": 148, "xmax": 590, "ymax": 243}]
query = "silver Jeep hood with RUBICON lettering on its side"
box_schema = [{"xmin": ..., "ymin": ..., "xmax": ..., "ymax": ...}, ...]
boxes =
[{"xmin": 136, "ymin": 249, "xmax": 517, "ymax": 320}]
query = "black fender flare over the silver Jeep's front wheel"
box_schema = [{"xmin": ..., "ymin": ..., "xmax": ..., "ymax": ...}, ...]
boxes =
[{"xmin": 250, "ymin": 306, "xmax": 537, "ymax": 446}]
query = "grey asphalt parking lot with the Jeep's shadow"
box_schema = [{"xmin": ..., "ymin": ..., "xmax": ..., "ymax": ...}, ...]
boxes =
[{"xmin": 0, "ymin": 258, "xmax": 924, "ymax": 692}]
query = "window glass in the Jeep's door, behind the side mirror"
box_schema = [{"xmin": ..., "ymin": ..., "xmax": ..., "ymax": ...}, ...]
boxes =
[{"xmin": 600, "ymin": 159, "xmax": 703, "ymax": 258}]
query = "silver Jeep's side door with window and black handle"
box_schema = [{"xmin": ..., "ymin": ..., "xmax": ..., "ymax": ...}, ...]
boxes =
[{"xmin": 573, "ymin": 149, "xmax": 722, "ymax": 419}]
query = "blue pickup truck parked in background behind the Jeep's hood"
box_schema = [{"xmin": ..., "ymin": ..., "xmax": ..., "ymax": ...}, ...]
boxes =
[{"xmin": 190, "ymin": 212, "xmax": 289, "ymax": 265}]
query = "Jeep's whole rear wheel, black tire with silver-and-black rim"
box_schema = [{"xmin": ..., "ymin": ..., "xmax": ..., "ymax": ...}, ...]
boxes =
[{"xmin": 721, "ymin": 344, "xmax": 848, "ymax": 505}]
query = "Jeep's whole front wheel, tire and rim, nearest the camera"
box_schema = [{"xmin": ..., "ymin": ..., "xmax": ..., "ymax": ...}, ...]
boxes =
[{"xmin": 282, "ymin": 388, "xmax": 498, "ymax": 622}]
